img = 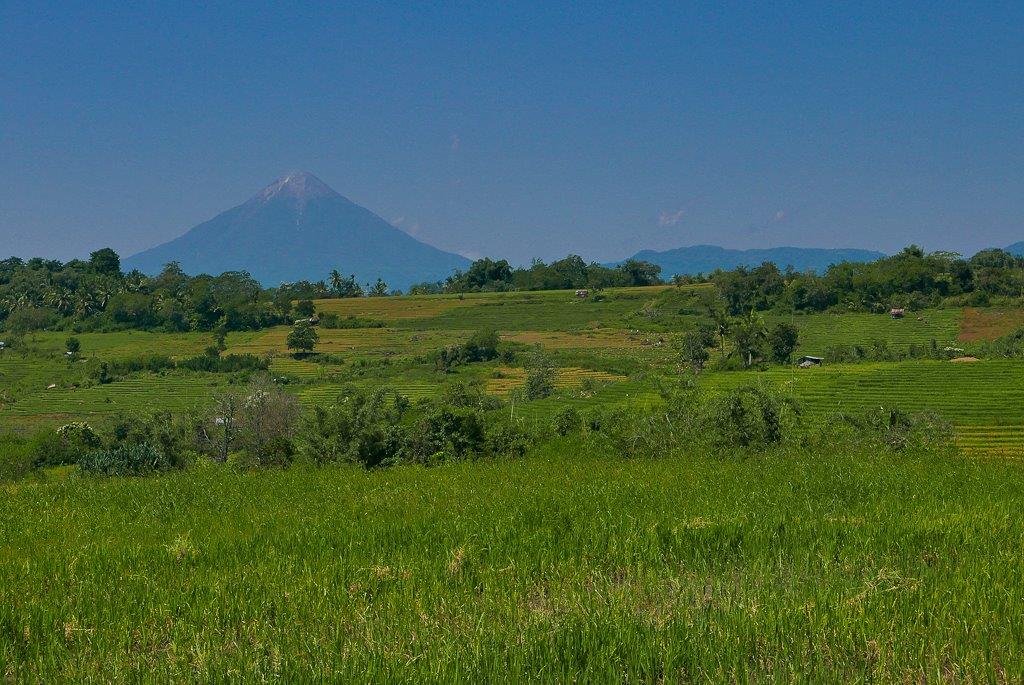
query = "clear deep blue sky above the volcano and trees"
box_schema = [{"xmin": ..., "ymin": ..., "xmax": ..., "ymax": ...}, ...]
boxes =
[{"xmin": 0, "ymin": 0, "xmax": 1024, "ymax": 262}]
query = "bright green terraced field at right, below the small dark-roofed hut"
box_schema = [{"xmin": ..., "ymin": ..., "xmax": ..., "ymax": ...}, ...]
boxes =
[{"xmin": 702, "ymin": 360, "xmax": 1024, "ymax": 459}]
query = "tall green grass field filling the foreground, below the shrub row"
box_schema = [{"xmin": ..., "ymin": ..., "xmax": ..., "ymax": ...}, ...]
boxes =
[{"xmin": 0, "ymin": 443, "xmax": 1024, "ymax": 682}]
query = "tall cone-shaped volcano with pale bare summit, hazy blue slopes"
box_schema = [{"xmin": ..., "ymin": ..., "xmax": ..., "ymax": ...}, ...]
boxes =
[{"xmin": 123, "ymin": 172, "xmax": 470, "ymax": 290}]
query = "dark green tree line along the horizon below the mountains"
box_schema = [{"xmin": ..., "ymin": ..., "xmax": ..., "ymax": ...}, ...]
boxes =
[{"xmin": 6, "ymin": 246, "xmax": 1024, "ymax": 334}]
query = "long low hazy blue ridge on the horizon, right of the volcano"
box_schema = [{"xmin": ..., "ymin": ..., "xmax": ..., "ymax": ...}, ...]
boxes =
[{"xmin": 617, "ymin": 245, "xmax": 886, "ymax": 277}]
